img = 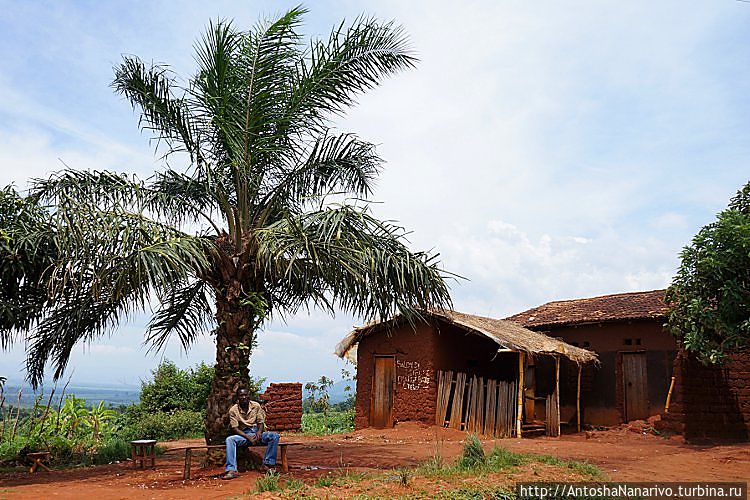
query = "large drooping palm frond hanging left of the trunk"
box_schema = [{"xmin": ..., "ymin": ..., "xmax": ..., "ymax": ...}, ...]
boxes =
[{"xmin": 22, "ymin": 202, "xmax": 213, "ymax": 384}]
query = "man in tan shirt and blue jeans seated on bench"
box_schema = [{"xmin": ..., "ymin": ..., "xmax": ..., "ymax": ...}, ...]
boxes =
[{"xmin": 222, "ymin": 389, "xmax": 279, "ymax": 479}]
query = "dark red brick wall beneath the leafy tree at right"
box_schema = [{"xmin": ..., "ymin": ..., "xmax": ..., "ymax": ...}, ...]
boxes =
[{"xmin": 659, "ymin": 351, "xmax": 750, "ymax": 441}]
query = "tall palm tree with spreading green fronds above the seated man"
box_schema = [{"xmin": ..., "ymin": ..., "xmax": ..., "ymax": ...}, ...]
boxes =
[{"xmin": 0, "ymin": 8, "xmax": 450, "ymax": 443}]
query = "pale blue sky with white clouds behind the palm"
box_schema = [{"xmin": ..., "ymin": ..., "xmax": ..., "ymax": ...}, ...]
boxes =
[{"xmin": 0, "ymin": 0, "xmax": 750, "ymax": 383}]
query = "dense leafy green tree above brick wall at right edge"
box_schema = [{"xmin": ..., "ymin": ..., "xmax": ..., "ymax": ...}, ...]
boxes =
[{"xmin": 666, "ymin": 183, "xmax": 750, "ymax": 364}]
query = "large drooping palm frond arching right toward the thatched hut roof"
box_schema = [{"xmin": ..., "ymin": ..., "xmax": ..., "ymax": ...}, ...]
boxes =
[{"xmin": 258, "ymin": 205, "xmax": 451, "ymax": 319}]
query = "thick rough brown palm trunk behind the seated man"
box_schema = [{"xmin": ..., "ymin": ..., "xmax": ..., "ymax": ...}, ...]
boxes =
[{"xmin": 206, "ymin": 294, "xmax": 255, "ymax": 445}]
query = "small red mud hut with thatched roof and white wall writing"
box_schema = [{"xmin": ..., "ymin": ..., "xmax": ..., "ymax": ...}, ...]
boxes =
[{"xmin": 336, "ymin": 311, "xmax": 596, "ymax": 436}]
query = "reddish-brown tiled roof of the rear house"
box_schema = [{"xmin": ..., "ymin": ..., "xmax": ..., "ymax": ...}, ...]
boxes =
[{"xmin": 505, "ymin": 290, "xmax": 668, "ymax": 330}]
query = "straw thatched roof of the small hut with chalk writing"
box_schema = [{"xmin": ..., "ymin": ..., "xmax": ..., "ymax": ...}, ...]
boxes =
[{"xmin": 336, "ymin": 310, "xmax": 597, "ymax": 363}]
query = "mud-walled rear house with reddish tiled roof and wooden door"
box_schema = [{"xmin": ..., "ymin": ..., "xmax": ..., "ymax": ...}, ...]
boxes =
[{"xmin": 506, "ymin": 290, "xmax": 678, "ymax": 425}]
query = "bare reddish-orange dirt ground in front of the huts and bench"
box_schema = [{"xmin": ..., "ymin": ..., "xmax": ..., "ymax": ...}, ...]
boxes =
[{"xmin": 0, "ymin": 423, "xmax": 750, "ymax": 500}]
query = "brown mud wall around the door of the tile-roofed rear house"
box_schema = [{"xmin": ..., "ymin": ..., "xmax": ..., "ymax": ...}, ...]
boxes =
[{"xmin": 546, "ymin": 319, "xmax": 677, "ymax": 426}]
